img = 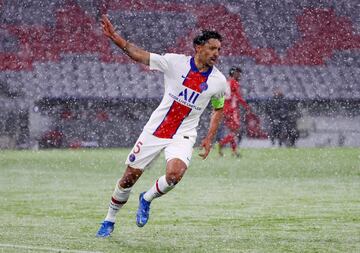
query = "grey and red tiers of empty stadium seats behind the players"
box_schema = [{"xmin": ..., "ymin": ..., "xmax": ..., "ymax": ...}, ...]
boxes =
[{"xmin": 0, "ymin": 0, "xmax": 360, "ymax": 145}]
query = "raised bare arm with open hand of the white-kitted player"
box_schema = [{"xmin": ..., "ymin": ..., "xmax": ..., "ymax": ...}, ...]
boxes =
[{"xmin": 101, "ymin": 15, "xmax": 150, "ymax": 65}]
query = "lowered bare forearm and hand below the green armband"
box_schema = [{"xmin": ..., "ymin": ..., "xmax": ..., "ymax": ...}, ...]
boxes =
[{"xmin": 199, "ymin": 108, "xmax": 223, "ymax": 159}]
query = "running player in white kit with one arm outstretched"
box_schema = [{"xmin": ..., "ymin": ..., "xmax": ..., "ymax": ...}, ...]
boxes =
[{"xmin": 96, "ymin": 16, "xmax": 227, "ymax": 237}]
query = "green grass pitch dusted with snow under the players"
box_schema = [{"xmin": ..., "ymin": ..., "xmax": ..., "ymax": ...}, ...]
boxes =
[{"xmin": 0, "ymin": 148, "xmax": 360, "ymax": 253}]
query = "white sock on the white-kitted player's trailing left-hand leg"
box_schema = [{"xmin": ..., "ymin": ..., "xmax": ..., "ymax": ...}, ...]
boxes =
[{"xmin": 105, "ymin": 181, "xmax": 131, "ymax": 222}]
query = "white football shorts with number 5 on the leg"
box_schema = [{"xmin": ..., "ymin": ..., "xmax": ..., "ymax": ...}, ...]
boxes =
[{"xmin": 125, "ymin": 131, "xmax": 195, "ymax": 170}]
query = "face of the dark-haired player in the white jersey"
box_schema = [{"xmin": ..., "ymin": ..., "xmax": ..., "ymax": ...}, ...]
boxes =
[{"xmin": 197, "ymin": 39, "xmax": 221, "ymax": 67}]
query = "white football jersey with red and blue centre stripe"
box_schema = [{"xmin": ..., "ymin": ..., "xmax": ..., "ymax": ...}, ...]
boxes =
[{"xmin": 144, "ymin": 53, "xmax": 227, "ymax": 138}]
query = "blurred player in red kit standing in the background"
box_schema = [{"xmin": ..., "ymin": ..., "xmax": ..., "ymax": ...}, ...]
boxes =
[{"xmin": 218, "ymin": 66, "xmax": 250, "ymax": 157}]
